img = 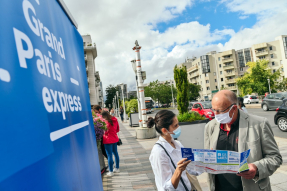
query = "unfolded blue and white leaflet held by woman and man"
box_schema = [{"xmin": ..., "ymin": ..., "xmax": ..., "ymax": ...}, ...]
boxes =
[{"xmin": 181, "ymin": 148, "xmax": 250, "ymax": 174}]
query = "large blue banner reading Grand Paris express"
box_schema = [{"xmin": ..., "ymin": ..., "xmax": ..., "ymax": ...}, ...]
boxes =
[{"xmin": 0, "ymin": 0, "xmax": 103, "ymax": 191}]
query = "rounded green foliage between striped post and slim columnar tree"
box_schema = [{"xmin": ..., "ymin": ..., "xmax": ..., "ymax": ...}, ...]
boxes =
[{"xmin": 145, "ymin": 80, "xmax": 177, "ymax": 104}]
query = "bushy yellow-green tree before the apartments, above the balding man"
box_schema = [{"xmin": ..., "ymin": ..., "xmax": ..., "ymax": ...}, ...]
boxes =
[{"xmin": 236, "ymin": 60, "xmax": 281, "ymax": 95}]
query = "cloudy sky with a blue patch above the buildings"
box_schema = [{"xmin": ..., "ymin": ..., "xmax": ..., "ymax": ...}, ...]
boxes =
[{"xmin": 64, "ymin": 0, "xmax": 287, "ymax": 98}]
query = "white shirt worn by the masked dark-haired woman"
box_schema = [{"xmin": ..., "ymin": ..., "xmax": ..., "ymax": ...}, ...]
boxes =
[{"xmin": 149, "ymin": 136, "xmax": 201, "ymax": 191}]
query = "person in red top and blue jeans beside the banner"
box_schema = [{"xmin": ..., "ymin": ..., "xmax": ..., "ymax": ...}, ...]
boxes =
[{"xmin": 102, "ymin": 111, "xmax": 120, "ymax": 176}]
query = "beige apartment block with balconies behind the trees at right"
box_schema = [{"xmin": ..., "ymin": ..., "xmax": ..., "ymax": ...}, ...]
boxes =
[{"xmin": 182, "ymin": 36, "xmax": 287, "ymax": 100}]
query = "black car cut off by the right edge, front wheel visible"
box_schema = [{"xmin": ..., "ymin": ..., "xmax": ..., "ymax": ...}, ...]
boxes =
[{"xmin": 274, "ymin": 99, "xmax": 287, "ymax": 132}]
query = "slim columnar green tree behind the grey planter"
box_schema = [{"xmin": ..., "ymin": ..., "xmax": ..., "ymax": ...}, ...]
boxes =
[{"xmin": 173, "ymin": 65, "xmax": 188, "ymax": 114}]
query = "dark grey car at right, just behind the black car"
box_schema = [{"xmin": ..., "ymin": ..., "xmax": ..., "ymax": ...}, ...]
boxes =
[{"xmin": 261, "ymin": 92, "xmax": 287, "ymax": 111}]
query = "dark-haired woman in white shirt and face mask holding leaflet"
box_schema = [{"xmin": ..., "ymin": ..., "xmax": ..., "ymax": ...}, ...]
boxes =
[{"xmin": 147, "ymin": 110, "xmax": 201, "ymax": 191}]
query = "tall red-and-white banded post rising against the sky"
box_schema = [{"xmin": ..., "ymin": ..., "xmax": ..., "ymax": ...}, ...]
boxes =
[{"xmin": 133, "ymin": 40, "xmax": 147, "ymax": 127}]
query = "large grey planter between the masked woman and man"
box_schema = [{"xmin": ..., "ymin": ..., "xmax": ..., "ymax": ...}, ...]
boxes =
[{"xmin": 178, "ymin": 119, "xmax": 209, "ymax": 149}]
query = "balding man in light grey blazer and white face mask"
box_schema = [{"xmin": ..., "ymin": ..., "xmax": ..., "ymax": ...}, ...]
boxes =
[{"xmin": 204, "ymin": 90, "xmax": 282, "ymax": 191}]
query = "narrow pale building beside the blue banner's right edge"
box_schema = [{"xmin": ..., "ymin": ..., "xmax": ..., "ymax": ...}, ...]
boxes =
[{"xmin": 82, "ymin": 35, "xmax": 102, "ymax": 105}]
